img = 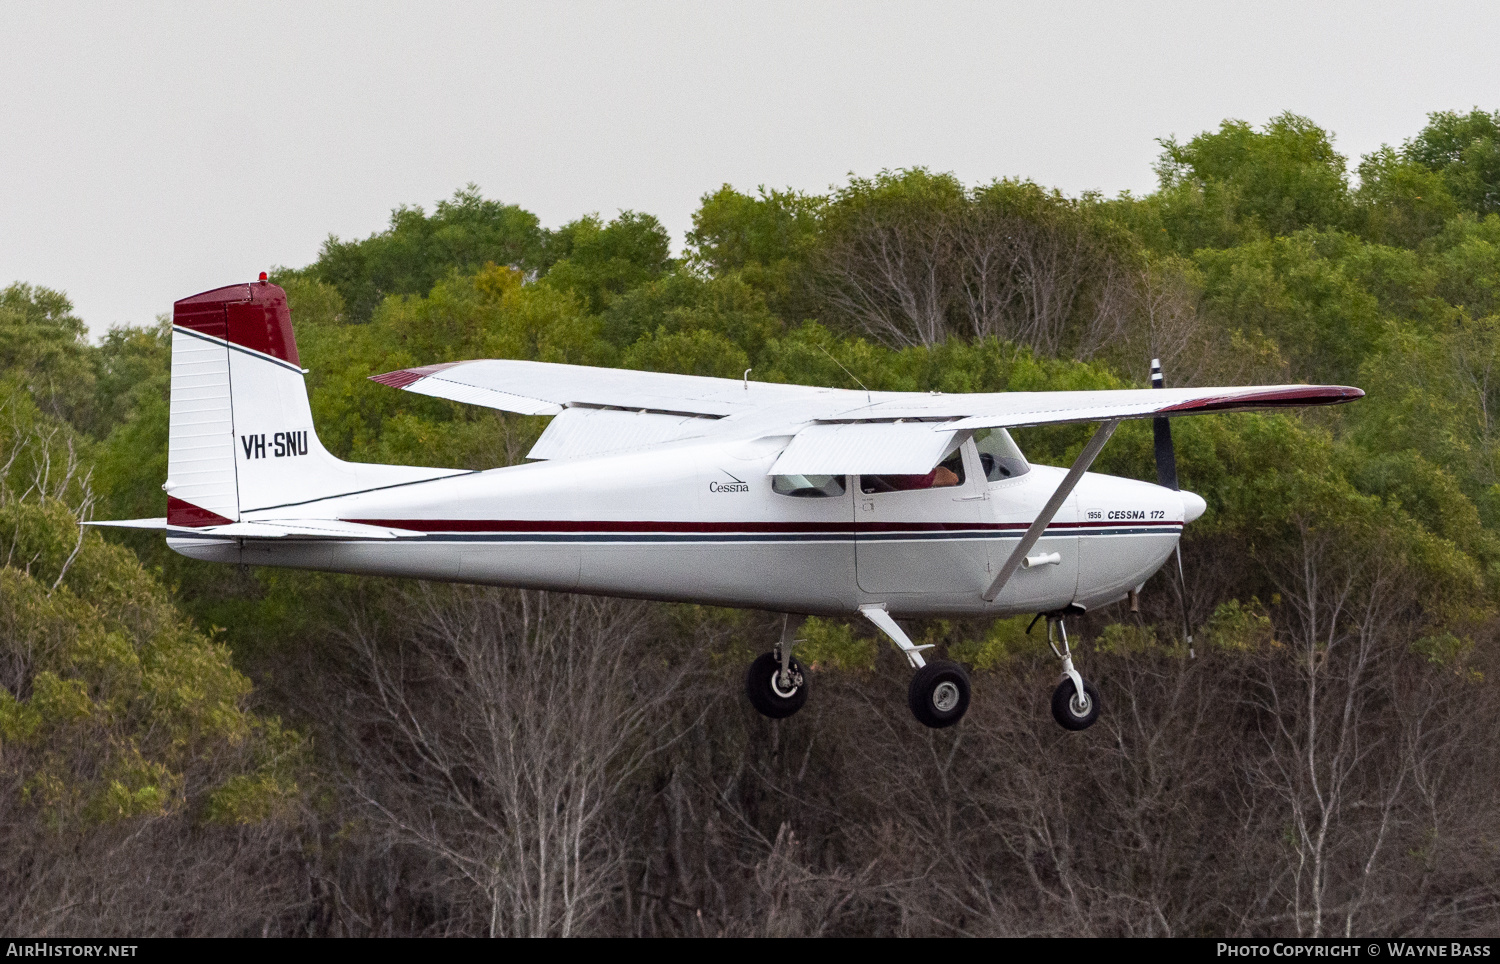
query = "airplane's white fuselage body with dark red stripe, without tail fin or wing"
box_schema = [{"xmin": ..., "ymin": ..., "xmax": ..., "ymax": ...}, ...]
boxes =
[{"xmin": 168, "ymin": 436, "xmax": 1185, "ymax": 616}]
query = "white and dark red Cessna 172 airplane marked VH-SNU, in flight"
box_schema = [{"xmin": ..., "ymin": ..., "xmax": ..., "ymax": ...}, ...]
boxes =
[{"xmin": 93, "ymin": 274, "xmax": 1364, "ymax": 730}]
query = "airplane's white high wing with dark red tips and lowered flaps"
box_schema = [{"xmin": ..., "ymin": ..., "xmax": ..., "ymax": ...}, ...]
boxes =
[{"xmin": 372, "ymin": 360, "xmax": 1365, "ymax": 474}]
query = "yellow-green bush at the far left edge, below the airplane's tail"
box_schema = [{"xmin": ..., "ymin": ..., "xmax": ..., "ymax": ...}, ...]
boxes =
[{"xmin": 0, "ymin": 384, "xmax": 305, "ymax": 832}]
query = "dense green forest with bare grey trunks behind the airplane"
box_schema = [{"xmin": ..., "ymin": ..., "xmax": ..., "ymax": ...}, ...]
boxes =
[{"xmin": 0, "ymin": 109, "xmax": 1500, "ymax": 936}]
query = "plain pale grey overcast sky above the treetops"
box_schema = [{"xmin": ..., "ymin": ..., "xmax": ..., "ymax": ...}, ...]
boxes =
[{"xmin": 0, "ymin": 0, "xmax": 1500, "ymax": 333}]
